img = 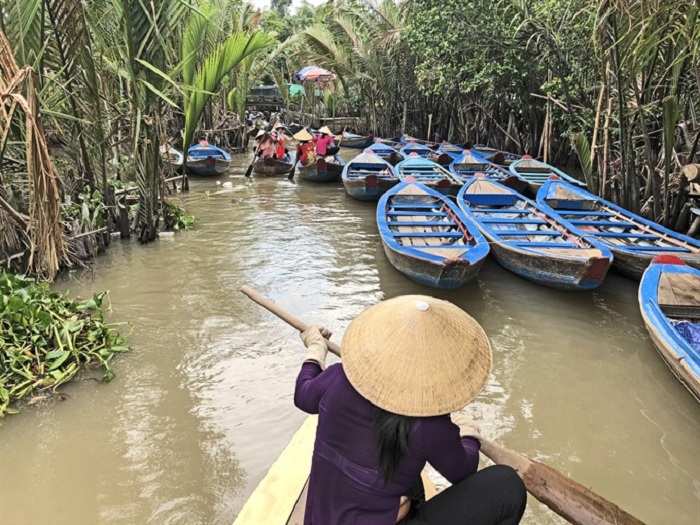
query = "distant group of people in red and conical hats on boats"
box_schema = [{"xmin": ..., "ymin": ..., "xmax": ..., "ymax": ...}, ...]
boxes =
[{"xmin": 255, "ymin": 122, "xmax": 340, "ymax": 165}]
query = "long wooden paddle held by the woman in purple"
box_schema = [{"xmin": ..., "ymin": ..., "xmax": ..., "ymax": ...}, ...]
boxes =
[{"xmin": 241, "ymin": 285, "xmax": 644, "ymax": 525}]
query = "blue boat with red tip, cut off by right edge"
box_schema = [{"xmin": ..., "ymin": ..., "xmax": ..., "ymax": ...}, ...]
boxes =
[{"xmin": 639, "ymin": 255, "xmax": 700, "ymax": 401}]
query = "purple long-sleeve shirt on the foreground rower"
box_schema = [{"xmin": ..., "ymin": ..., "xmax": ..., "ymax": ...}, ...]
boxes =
[{"xmin": 294, "ymin": 362, "xmax": 479, "ymax": 525}]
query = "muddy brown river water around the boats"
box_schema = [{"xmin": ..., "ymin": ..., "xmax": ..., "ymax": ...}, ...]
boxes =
[{"xmin": 0, "ymin": 150, "xmax": 700, "ymax": 525}]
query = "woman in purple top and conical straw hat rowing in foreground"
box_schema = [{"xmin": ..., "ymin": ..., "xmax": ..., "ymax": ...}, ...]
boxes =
[{"xmin": 294, "ymin": 295, "xmax": 527, "ymax": 525}]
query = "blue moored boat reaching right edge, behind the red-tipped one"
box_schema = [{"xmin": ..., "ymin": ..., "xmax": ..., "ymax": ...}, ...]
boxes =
[{"xmin": 537, "ymin": 178, "xmax": 700, "ymax": 279}]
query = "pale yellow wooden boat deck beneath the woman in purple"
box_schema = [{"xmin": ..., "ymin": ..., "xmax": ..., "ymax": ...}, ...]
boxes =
[{"xmin": 233, "ymin": 416, "xmax": 437, "ymax": 525}]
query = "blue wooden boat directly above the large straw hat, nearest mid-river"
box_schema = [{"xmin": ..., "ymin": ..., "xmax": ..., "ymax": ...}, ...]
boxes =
[{"xmin": 377, "ymin": 182, "xmax": 489, "ymax": 289}]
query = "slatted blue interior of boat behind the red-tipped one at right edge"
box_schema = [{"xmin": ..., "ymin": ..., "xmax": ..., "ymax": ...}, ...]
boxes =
[{"xmin": 545, "ymin": 184, "xmax": 700, "ymax": 254}]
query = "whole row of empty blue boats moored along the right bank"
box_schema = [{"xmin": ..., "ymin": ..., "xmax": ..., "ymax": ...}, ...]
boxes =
[{"xmin": 302, "ymin": 136, "xmax": 700, "ymax": 400}]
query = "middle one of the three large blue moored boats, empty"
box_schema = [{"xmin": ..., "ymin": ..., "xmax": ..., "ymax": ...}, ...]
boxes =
[{"xmin": 457, "ymin": 176, "xmax": 613, "ymax": 290}]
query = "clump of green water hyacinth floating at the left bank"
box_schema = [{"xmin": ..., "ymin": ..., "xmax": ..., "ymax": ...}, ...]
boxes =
[{"xmin": 0, "ymin": 272, "xmax": 129, "ymax": 418}]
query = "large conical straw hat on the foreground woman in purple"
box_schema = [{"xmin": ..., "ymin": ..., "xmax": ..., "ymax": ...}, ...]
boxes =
[{"xmin": 341, "ymin": 295, "xmax": 491, "ymax": 417}]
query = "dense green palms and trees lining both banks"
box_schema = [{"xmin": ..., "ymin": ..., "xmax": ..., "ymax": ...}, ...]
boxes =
[{"xmin": 0, "ymin": 0, "xmax": 700, "ymax": 279}]
